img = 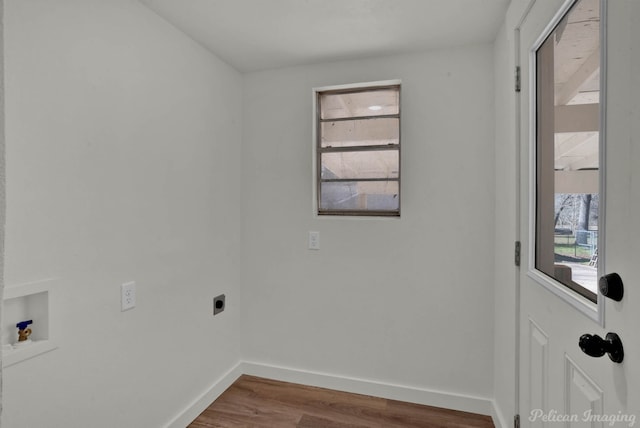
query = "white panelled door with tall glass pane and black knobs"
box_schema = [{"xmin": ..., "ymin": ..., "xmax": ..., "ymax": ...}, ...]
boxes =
[{"xmin": 516, "ymin": 0, "xmax": 640, "ymax": 427}]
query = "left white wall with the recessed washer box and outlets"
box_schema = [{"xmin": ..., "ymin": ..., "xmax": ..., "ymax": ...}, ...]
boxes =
[{"xmin": 2, "ymin": 0, "xmax": 242, "ymax": 428}]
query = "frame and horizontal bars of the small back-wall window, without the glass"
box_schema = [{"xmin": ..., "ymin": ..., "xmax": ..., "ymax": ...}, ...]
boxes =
[{"xmin": 312, "ymin": 79, "xmax": 402, "ymax": 218}]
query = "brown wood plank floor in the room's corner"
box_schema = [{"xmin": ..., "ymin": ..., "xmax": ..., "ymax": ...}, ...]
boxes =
[{"xmin": 189, "ymin": 375, "xmax": 493, "ymax": 428}]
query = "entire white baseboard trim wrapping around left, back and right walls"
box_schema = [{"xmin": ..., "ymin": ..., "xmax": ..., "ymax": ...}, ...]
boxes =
[{"xmin": 165, "ymin": 361, "xmax": 500, "ymax": 428}]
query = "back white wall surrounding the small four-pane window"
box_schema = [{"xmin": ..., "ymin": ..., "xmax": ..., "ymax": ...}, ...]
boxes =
[{"xmin": 242, "ymin": 45, "xmax": 495, "ymax": 398}]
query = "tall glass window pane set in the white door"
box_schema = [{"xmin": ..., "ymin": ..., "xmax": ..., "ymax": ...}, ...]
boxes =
[{"xmin": 535, "ymin": 0, "xmax": 603, "ymax": 302}]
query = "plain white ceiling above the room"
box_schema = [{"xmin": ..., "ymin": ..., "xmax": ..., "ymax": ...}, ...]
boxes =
[{"xmin": 141, "ymin": 0, "xmax": 510, "ymax": 72}]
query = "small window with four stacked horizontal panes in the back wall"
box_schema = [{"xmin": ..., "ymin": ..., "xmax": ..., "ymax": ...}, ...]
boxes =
[{"xmin": 316, "ymin": 84, "xmax": 400, "ymax": 217}]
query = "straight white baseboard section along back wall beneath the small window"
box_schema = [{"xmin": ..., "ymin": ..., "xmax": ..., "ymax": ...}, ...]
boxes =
[{"xmin": 242, "ymin": 361, "xmax": 494, "ymax": 415}]
